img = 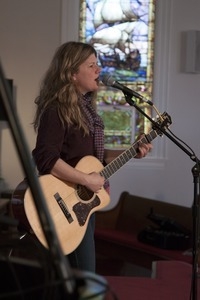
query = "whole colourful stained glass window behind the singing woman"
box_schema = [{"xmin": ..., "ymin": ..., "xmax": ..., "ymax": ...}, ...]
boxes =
[{"xmin": 79, "ymin": 0, "xmax": 155, "ymax": 148}]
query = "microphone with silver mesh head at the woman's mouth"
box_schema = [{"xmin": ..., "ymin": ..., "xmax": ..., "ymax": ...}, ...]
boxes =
[{"xmin": 102, "ymin": 75, "xmax": 153, "ymax": 105}]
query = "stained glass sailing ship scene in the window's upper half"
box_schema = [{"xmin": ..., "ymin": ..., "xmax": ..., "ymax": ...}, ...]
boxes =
[{"xmin": 80, "ymin": 0, "xmax": 154, "ymax": 83}]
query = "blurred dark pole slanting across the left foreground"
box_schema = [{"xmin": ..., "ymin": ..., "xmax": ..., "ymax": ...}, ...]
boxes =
[{"xmin": 0, "ymin": 63, "xmax": 77, "ymax": 299}]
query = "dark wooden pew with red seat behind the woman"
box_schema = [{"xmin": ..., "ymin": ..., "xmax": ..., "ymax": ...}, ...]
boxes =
[{"xmin": 95, "ymin": 192, "xmax": 193, "ymax": 270}]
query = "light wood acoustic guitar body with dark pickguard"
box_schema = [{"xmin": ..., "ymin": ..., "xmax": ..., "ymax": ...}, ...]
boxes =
[{"xmin": 12, "ymin": 156, "xmax": 110, "ymax": 254}]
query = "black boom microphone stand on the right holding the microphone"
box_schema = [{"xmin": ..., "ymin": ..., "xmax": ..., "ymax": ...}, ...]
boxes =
[{"xmin": 124, "ymin": 93, "xmax": 200, "ymax": 300}]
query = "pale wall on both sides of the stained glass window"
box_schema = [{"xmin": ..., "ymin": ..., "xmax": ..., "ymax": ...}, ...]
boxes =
[{"xmin": 0, "ymin": 0, "xmax": 200, "ymax": 206}]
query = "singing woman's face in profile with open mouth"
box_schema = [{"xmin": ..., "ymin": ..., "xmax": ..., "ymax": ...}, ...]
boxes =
[{"xmin": 73, "ymin": 54, "xmax": 101, "ymax": 95}]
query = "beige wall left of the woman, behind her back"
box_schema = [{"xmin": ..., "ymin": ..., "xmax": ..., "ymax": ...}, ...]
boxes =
[{"xmin": 0, "ymin": 0, "xmax": 61, "ymax": 188}]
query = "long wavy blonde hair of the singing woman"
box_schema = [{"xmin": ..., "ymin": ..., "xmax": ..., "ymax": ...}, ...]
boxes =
[{"xmin": 33, "ymin": 42, "xmax": 97, "ymax": 134}]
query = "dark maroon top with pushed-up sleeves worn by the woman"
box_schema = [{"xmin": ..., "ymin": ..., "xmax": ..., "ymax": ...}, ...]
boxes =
[{"xmin": 32, "ymin": 108, "xmax": 94, "ymax": 175}]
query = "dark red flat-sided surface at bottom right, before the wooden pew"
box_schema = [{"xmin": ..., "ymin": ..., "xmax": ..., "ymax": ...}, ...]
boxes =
[{"xmin": 105, "ymin": 261, "xmax": 200, "ymax": 300}]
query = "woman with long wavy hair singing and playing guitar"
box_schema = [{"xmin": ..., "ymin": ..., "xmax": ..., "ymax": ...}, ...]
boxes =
[{"xmin": 32, "ymin": 42, "xmax": 151, "ymax": 272}]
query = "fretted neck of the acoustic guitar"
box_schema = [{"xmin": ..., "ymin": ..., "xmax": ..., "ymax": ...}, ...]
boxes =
[{"xmin": 100, "ymin": 130, "xmax": 158, "ymax": 180}]
